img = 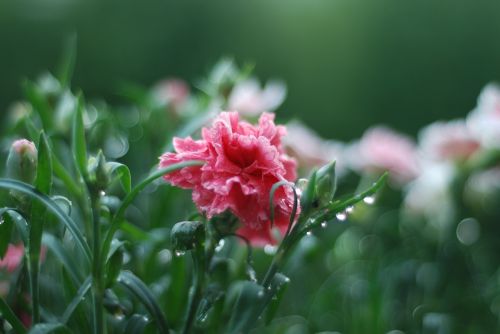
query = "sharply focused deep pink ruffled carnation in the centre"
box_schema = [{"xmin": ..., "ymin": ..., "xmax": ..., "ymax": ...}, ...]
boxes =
[{"xmin": 160, "ymin": 112, "xmax": 296, "ymax": 245}]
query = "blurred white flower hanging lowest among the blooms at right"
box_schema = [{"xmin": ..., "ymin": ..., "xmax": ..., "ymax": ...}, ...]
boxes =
[{"xmin": 404, "ymin": 162, "xmax": 455, "ymax": 222}]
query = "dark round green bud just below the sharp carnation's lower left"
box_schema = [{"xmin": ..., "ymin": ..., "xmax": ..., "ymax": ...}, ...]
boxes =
[{"xmin": 170, "ymin": 221, "xmax": 205, "ymax": 252}]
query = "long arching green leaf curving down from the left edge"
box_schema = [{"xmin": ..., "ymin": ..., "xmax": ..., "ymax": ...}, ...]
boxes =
[{"xmin": 0, "ymin": 178, "xmax": 90, "ymax": 264}]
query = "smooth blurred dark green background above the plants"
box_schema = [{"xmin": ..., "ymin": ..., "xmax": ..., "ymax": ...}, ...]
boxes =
[{"xmin": 0, "ymin": 0, "xmax": 500, "ymax": 140}]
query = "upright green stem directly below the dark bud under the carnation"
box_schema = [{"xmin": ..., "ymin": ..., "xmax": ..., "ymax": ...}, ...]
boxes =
[{"xmin": 182, "ymin": 245, "xmax": 205, "ymax": 334}]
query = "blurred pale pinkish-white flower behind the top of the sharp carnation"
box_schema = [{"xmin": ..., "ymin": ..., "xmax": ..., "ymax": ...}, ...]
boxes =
[{"xmin": 228, "ymin": 79, "xmax": 286, "ymax": 116}]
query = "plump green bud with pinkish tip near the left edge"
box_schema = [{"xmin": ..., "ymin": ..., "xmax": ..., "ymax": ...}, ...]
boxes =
[{"xmin": 7, "ymin": 139, "xmax": 38, "ymax": 184}]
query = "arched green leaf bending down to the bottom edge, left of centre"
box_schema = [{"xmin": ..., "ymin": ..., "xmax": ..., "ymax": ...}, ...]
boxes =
[{"xmin": 118, "ymin": 271, "xmax": 169, "ymax": 334}]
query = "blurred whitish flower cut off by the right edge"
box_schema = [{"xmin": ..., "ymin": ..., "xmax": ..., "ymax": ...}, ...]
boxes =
[{"xmin": 467, "ymin": 84, "xmax": 500, "ymax": 147}]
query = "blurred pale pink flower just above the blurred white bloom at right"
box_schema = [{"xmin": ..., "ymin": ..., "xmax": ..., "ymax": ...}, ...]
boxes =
[{"xmin": 419, "ymin": 119, "xmax": 480, "ymax": 161}]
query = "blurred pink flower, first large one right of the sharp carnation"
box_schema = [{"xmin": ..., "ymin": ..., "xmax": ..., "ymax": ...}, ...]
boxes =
[{"xmin": 348, "ymin": 126, "xmax": 419, "ymax": 184}]
